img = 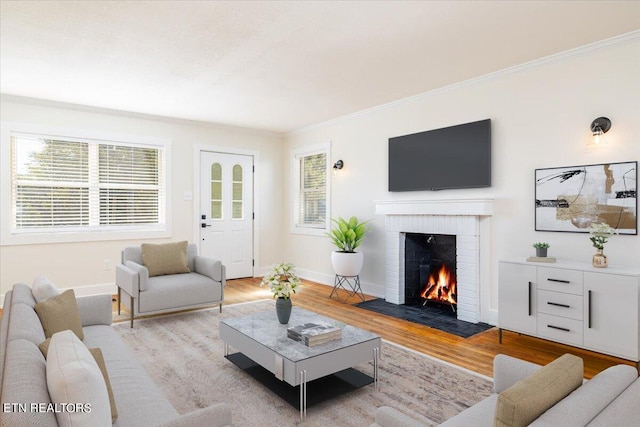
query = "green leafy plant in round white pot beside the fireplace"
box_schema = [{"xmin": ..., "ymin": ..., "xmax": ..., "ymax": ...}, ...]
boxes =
[{"xmin": 327, "ymin": 216, "xmax": 369, "ymax": 277}]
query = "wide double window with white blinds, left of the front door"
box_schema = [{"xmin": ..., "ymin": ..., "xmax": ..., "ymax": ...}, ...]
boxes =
[{"xmin": 11, "ymin": 134, "xmax": 165, "ymax": 234}]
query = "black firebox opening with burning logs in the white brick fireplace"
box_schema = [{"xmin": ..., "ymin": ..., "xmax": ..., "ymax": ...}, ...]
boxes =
[{"xmin": 404, "ymin": 233, "xmax": 457, "ymax": 316}]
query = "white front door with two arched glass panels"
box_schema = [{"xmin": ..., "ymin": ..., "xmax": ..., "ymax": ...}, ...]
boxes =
[{"xmin": 200, "ymin": 151, "xmax": 253, "ymax": 279}]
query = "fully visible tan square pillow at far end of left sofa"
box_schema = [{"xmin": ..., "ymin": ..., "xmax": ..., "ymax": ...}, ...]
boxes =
[{"xmin": 35, "ymin": 289, "xmax": 84, "ymax": 340}]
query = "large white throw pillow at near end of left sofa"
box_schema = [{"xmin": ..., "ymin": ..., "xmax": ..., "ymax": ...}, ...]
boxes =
[{"xmin": 47, "ymin": 330, "xmax": 111, "ymax": 427}]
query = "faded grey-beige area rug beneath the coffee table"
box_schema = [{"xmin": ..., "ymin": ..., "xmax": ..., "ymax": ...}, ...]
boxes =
[{"xmin": 114, "ymin": 300, "xmax": 493, "ymax": 427}]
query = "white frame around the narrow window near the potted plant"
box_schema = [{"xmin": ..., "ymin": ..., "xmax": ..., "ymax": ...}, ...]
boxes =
[{"xmin": 290, "ymin": 142, "xmax": 331, "ymax": 236}]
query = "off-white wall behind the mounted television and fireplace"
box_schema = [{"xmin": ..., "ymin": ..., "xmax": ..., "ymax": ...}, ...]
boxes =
[{"xmin": 285, "ymin": 34, "xmax": 640, "ymax": 321}]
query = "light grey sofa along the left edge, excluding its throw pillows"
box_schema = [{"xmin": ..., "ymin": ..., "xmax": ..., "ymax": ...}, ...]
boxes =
[{"xmin": 0, "ymin": 284, "xmax": 232, "ymax": 427}]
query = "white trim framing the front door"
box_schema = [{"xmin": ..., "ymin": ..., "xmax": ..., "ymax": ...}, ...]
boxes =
[{"xmin": 191, "ymin": 144, "xmax": 260, "ymax": 277}]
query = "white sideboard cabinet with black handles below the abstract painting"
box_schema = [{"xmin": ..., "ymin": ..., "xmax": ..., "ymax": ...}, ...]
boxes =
[{"xmin": 498, "ymin": 260, "xmax": 640, "ymax": 368}]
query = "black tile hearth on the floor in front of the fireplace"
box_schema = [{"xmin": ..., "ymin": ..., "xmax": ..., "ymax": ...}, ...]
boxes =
[{"xmin": 355, "ymin": 298, "xmax": 493, "ymax": 338}]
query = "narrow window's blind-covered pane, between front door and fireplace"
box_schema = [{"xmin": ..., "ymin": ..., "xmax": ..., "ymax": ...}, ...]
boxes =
[{"xmin": 294, "ymin": 150, "xmax": 328, "ymax": 234}]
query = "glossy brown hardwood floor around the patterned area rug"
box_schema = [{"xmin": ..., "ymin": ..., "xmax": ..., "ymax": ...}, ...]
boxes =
[{"xmin": 224, "ymin": 278, "xmax": 634, "ymax": 378}]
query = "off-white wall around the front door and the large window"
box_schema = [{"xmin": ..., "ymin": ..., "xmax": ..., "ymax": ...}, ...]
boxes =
[{"xmin": 0, "ymin": 96, "xmax": 284, "ymax": 296}]
